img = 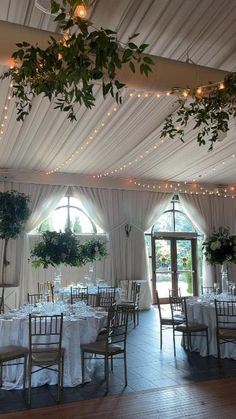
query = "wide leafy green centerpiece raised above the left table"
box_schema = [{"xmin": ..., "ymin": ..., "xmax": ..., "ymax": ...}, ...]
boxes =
[{"xmin": 30, "ymin": 230, "xmax": 107, "ymax": 268}]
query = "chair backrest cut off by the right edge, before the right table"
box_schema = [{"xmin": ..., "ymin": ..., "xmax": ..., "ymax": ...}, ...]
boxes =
[{"xmin": 215, "ymin": 299, "xmax": 236, "ymax": 329}]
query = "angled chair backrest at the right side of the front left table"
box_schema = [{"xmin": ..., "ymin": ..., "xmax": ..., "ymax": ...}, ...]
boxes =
[{"xmin": 106, "ymin": 305, "xmax": 130, "ymax": 349}]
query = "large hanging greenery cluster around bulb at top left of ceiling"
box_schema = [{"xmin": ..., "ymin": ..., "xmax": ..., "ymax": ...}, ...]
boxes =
[{"xmin": 1, "ymin": 0, "xmax": 153, "ymax": 121}]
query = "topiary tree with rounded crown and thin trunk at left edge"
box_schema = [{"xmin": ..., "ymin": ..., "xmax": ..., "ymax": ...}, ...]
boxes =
[{"xmin": 0, "ymin": 190, "xmax": 30, "ymax": 309}]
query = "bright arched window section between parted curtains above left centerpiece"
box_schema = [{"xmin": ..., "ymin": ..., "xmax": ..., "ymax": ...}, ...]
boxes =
[{"xmin": 31, "ymin": 196, "xmax": 104, "ymax": 234}]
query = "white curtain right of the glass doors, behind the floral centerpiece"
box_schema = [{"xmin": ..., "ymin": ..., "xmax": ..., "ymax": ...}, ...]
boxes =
[{"xmin": 180, "ymin": 194, "xmax": 236, "ymax": 285}]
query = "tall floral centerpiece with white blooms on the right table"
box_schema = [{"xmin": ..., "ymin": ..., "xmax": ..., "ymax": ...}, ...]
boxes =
[{"xmin": 202, "ymin": 227, "xmax": 236, "ymax": 292}]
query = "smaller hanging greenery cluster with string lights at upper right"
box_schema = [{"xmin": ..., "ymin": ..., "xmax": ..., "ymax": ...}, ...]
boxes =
[{"xmin": 161, "ymin": 73, "xmax": 236, "ymax": 150}]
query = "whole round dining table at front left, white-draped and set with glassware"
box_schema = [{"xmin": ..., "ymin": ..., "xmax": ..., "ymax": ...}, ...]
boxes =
[{"xmin": 0, "ymin": 303, "xmax": 107, "ymax": 390}]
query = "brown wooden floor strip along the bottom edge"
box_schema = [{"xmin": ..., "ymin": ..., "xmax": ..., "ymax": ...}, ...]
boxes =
[{"xmin": 1, "ymin": 378, "xmax": 236, "ymax": 419}]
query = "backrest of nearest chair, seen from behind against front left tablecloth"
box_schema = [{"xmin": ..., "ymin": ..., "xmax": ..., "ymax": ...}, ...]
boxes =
[{"xmin": 29, "ymin": 313, "xmax": 63, "ymax": 354}]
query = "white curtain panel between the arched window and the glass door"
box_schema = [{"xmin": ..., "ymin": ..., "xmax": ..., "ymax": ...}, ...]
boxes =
[{"xmin": 73, "ymin": 187, "xmax": 172, "ymax": 309}]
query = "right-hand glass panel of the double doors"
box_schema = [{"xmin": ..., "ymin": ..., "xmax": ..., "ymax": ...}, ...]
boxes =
[{"xmin": 176, "ymin": 240, "xmax": 193, "ymax": 296}]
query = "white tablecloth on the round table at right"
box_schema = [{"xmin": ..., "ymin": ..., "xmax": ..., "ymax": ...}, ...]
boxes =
[{"xmin": 187, "ymin": 297, "xmax": 236, "ymax": 359}]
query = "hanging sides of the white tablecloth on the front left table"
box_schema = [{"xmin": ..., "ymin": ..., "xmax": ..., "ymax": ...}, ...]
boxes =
[{"xmin": 0, "ymin": 313, "xmax": 106, "ymax": 390}]
